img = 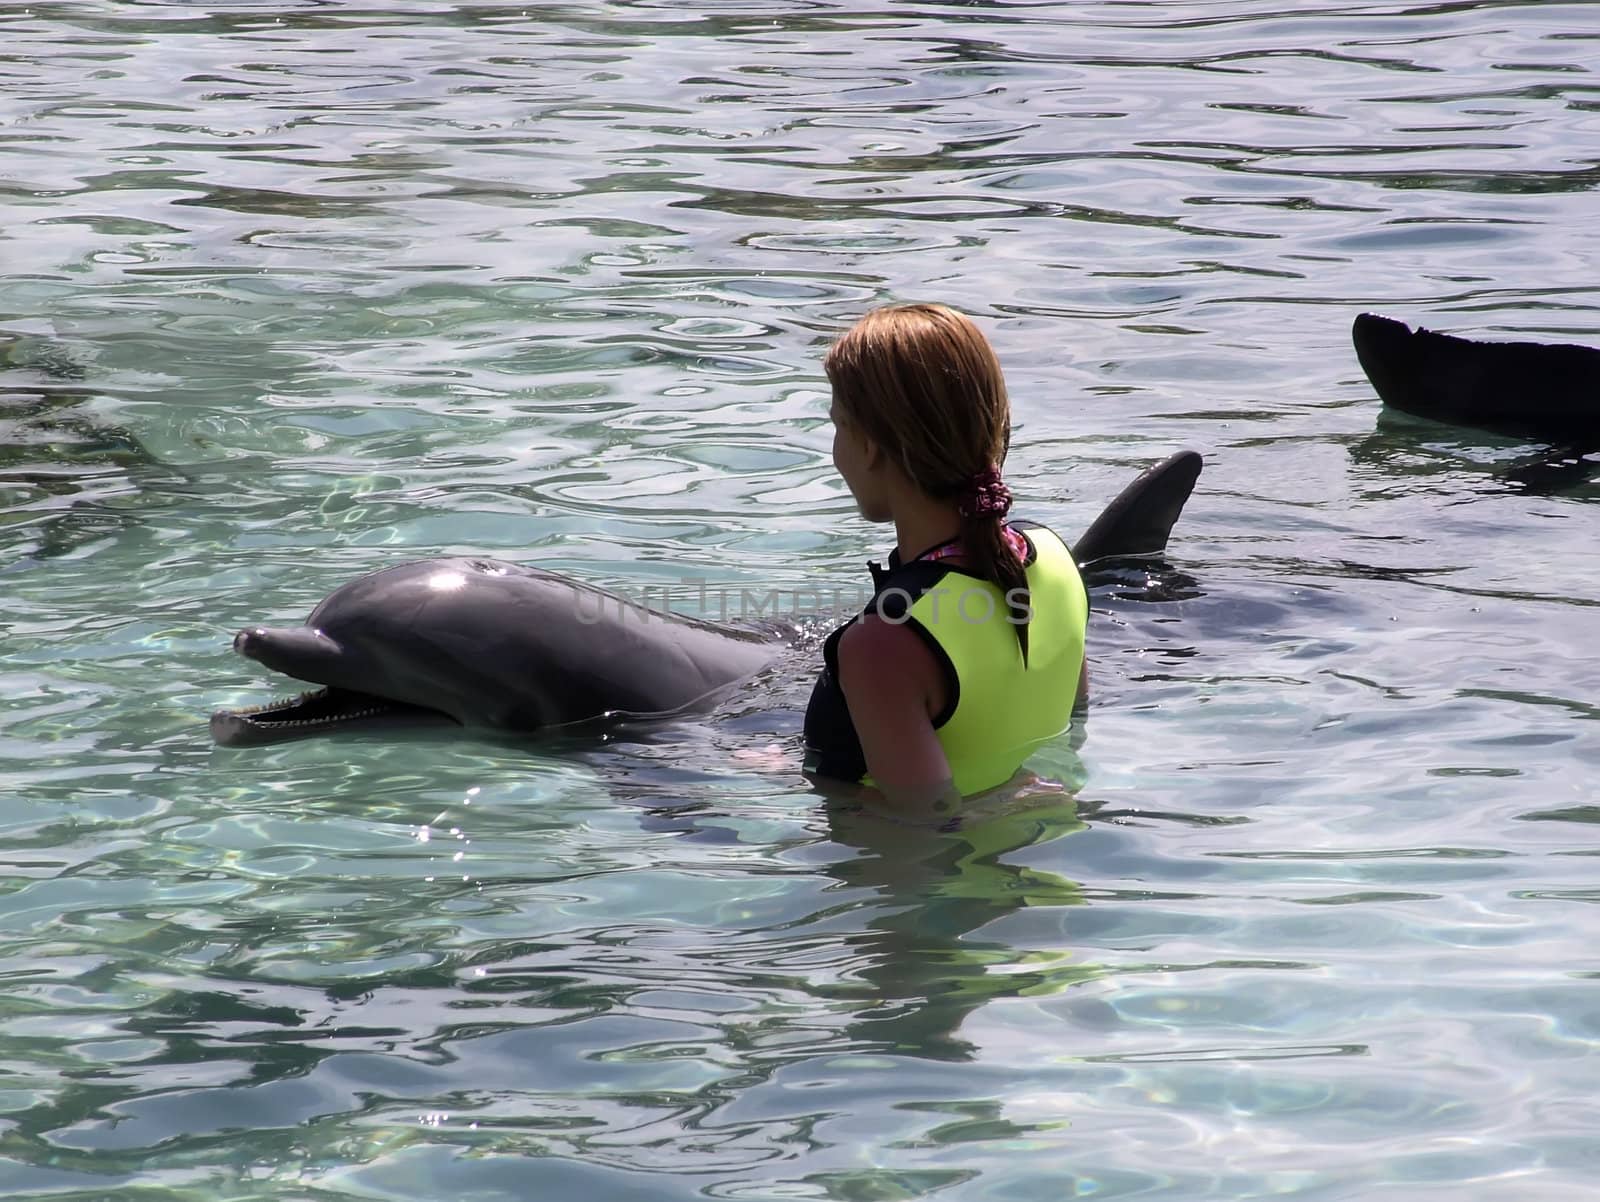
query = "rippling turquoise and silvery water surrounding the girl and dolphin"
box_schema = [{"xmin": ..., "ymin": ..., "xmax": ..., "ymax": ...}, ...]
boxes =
[{"xmin": 0, "ymin": 0, "xmax": 1600, "ymax": 1202}]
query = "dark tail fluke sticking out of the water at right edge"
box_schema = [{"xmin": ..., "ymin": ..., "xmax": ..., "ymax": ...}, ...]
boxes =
[{"xmin": 1350, "ymin": 314, "xmax": 1600, "ymax": 447}]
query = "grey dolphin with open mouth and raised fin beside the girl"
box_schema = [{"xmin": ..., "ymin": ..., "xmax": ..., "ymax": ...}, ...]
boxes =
[{"xmin": 211, "ymin": 451, "xmax": 1202, "ymax": 747}]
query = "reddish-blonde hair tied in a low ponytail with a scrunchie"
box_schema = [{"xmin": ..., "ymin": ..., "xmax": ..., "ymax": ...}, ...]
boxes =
[{"xmin": 822, "ymin": 304, "xmax": 1027, "ymax": 661}]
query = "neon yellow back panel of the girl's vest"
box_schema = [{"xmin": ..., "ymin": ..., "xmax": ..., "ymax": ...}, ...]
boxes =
[{"xmin": 907, "ymin": 523, "xmax": 1090, "ymax": 794}]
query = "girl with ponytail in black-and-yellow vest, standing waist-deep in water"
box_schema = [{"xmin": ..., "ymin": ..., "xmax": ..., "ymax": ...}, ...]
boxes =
[{"xmin": 805, "ymin": 304, "xmax": 1088, "ymax": 813}]
